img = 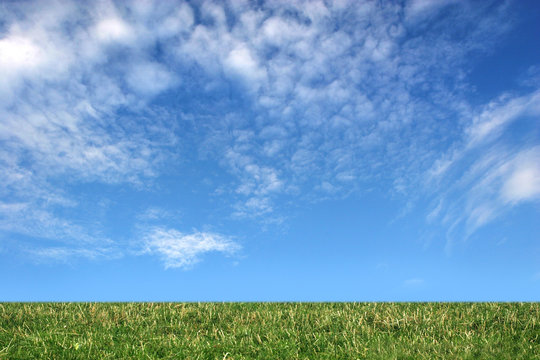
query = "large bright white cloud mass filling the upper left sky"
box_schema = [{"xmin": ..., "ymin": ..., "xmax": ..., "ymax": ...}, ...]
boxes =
[{"xmin": 0, "ymin": 1, "xmax": 181, "ymax": 254}]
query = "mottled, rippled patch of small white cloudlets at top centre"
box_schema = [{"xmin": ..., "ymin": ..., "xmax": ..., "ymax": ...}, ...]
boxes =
[{"xmin": 176, "ymin": 2, "xmax": 520, "ymax": 216}]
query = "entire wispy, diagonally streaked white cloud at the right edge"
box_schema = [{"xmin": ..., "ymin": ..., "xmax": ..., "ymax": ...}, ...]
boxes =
[{"xmin": 426, "ymin": 90, "xmax": 540, "ymax": 240}]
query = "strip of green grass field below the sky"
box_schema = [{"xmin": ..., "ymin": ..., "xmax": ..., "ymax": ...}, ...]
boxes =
[{"xmin": 0, "ymin": 303, "xmax": 540, "ymax": 360}]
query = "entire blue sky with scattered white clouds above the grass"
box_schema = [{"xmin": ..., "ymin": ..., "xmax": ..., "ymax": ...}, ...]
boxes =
[{"xmin": 0, "ymin": 0, "xmax": 540, "ymax": 301}]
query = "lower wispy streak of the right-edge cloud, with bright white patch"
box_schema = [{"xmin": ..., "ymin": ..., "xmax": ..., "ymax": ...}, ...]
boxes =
[{"xmin": 427, "ymin": 146, "xmax": 540, "ymax": 240}]
